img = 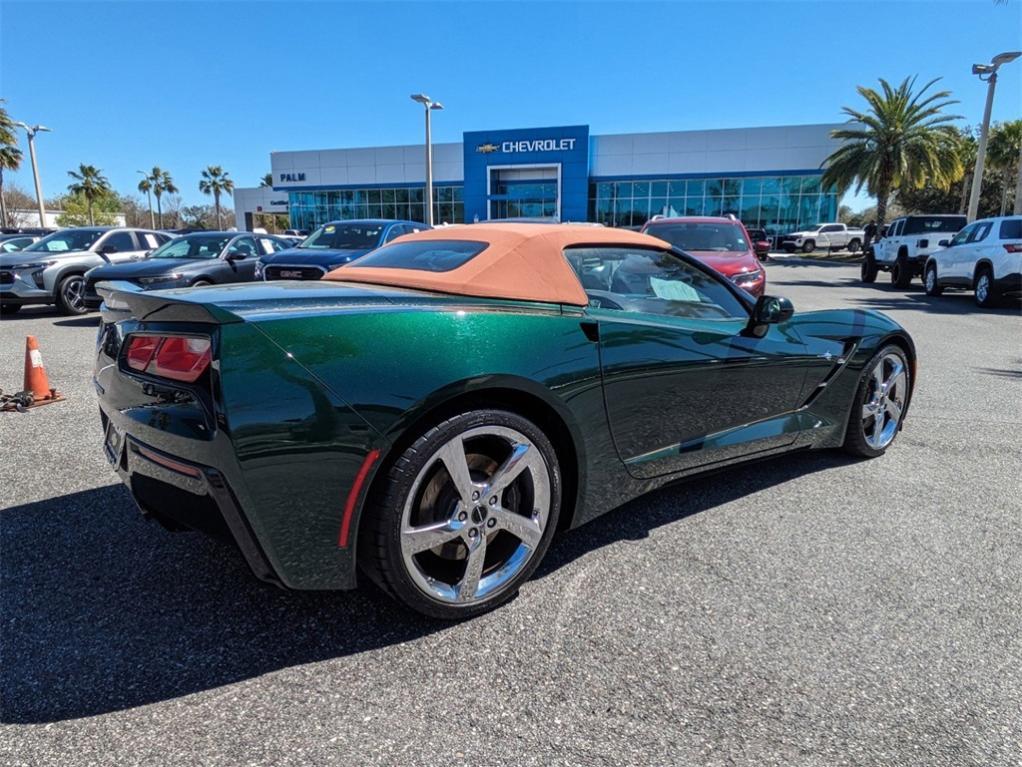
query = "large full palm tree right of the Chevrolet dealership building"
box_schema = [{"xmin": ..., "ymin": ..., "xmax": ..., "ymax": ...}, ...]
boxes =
[{"xmin": 823, "ymin": 78, "xmax": 963, "ymax": 227}]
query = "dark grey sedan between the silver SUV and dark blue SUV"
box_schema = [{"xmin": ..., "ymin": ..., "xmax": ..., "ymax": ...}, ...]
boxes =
[{"xmin": 85, "ymin": 232, "xmax": 287, "ymax": 308}]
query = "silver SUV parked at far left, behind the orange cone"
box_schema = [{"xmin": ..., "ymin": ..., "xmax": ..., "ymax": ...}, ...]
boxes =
[{"xmin": 0, "ymin": 226, "xmax": 171, "ymax": 315}]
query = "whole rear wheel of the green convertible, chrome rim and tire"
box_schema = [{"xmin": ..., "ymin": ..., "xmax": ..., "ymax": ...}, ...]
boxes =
[{"xmin": 360, "ymin": 410, "xmax": 561, "ymax": 619}]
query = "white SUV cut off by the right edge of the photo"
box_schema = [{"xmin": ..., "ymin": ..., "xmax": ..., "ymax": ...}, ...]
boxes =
[{"xmin": 923, "ymin": 216, "xmax": 1022, "ymax": 307}]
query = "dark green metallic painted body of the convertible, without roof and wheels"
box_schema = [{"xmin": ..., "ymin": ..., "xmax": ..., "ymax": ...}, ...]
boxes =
[{"xmin": 96, "ymin": 283, "xmax": 914, "ymax": 589}]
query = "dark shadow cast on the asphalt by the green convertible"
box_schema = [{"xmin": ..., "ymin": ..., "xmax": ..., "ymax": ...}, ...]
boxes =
[{"xmin": 0, "ymin": 453, "xmax": 848, "ymax": 723}]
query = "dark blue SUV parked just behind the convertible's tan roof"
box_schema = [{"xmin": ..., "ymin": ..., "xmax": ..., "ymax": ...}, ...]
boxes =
[{"xmin": 256, "ymin": 219, "xmax": 429, "ymax": 280}]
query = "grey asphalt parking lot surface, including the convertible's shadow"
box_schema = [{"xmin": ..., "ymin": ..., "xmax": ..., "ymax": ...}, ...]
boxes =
[{"xmin": 0, "ymin": 259, "xmax": 1022, "ymax": 767}]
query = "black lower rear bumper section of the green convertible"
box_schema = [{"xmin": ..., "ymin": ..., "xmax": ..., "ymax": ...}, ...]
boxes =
[{"xmin": 100, "ymin": 407, "xmax": 283, "ymax": 586}]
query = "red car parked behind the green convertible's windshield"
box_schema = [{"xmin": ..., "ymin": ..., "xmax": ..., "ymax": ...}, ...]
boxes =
[{"xmin": 642, "ymin": 216, "xmax": 767, "ymax": 298}]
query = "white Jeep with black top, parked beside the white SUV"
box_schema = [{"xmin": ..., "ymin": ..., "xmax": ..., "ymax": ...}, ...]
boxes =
[{"xmin": 862, "ymin": 214, "xmax": 968, "ymax": 287}]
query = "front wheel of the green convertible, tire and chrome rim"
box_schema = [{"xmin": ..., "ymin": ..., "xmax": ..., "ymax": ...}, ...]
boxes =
[{"xmin": 844, "ymin": 345, "xmax": 910, "ymax": 458}]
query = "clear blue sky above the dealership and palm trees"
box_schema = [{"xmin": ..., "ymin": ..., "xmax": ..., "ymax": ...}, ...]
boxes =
[{"xmin": 0, "ymin": 0, "xmax": 1022, "ymax": 210}]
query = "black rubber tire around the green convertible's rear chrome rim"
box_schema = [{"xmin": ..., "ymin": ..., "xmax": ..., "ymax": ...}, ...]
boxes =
[{"xmin": 359, "ymin": 409, "xmax": 561, "ymax": 620}]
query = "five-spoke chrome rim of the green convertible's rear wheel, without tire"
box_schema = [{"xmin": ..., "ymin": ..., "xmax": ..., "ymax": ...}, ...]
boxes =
[{"xmin": 401, "ymin": 425, "xmax": 551, "ymax": 604}]
